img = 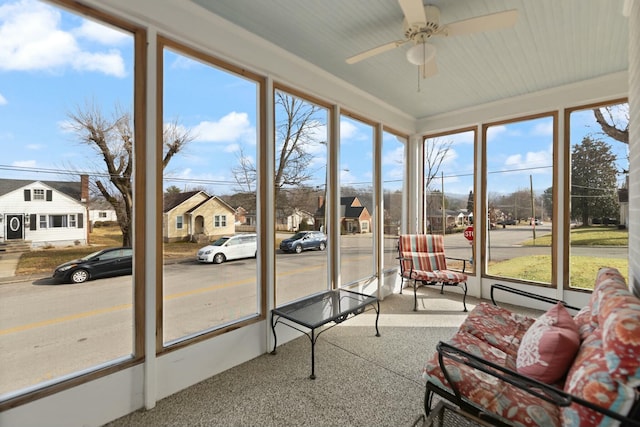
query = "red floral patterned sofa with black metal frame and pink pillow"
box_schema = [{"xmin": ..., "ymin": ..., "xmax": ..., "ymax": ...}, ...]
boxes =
[{"xmin": 423, "ymin": 268, "xmax": 640, "ymax": 427}]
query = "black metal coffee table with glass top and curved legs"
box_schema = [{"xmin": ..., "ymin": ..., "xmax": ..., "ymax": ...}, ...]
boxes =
[{"xmin": 271, "ymin": 289, "xmax": 380, "ymax": 380}]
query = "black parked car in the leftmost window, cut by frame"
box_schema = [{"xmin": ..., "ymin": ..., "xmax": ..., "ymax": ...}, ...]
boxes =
[{"xmin": 53, "ymin": 248, "xmax": 133, "ymax": 283}]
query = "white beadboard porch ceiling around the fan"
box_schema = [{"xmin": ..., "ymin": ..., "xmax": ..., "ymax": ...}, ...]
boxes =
[{"xmin": 192, "ymin": 0, "xmax": 628, "ymax": 119}]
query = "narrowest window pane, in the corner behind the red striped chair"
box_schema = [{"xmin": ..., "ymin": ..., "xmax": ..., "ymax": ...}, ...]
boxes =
[{"xmin": 382, "ymin": 132, "xmax": 407, "ymax": 270}]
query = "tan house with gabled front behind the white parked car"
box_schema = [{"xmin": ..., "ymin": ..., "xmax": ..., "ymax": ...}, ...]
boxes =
[{"xmin": 162, "ymin": 191, "xmax": 236, "ymax": 243}]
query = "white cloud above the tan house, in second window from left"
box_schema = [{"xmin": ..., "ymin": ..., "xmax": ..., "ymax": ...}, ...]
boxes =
[{"xmin": 193, "ymin": 111, "xmax": 255, "ymax": 142}]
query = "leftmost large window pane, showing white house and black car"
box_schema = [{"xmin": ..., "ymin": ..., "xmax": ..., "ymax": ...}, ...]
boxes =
[{"xmin": 0, "ymin": 1, "xmax": 135, "ymax": 396}]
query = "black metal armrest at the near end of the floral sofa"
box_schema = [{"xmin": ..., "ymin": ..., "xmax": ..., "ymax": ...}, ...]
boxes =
[{"xmin": 436, "ymin": 341, "xmax": 640, "ymax": 427}]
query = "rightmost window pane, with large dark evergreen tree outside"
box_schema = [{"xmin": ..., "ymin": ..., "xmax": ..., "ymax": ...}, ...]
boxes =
[{"xmin": 569, "ymin": 103, "xmax": 629, "ymax": 289}]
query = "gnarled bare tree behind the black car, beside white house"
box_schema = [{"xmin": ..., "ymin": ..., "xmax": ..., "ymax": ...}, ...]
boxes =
[{"xmin": 68, "ymin": 103, "xmax": 193, "ymax": 246}]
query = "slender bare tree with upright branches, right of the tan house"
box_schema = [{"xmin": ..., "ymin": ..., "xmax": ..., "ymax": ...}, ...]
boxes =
[{"xmin": 232, "ymin": 91, "xmax": 324, "ymax": 200}]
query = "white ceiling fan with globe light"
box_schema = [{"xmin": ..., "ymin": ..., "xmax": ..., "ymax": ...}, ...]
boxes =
[{"xmin": 347, "ymin": 0, "xmax": 518, "ymax": 77}]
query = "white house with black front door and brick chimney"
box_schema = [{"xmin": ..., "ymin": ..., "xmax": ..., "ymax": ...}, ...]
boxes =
[{"xmin": 0, "ymin": 175, "xmax": 89, "ymax": 248}]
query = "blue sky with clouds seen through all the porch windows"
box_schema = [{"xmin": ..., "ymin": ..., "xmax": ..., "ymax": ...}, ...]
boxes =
[{"xmin": 0, "ymin": 0, "xmax": 626, "ymax": 201}]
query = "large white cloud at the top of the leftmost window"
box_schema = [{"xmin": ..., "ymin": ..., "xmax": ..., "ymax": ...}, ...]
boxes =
[{"xmin": 0, "ymin": 0, "xmax": 126, "ymax": 77}]
